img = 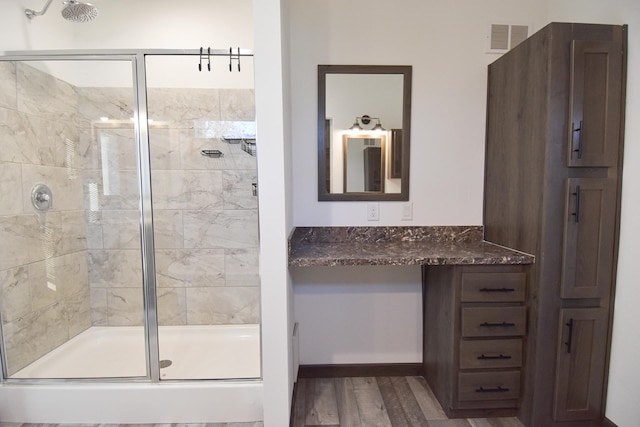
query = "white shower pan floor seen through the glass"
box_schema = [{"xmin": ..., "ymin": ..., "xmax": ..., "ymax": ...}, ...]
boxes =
[{"xmin": 10, "ymin": 324, "xmax": 260, "ymax": 380}]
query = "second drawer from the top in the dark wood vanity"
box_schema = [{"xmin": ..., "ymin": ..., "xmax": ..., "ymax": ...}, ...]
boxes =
[{"xmin": 461, "ymin": 307, "xmax": 526, "ymax": 337}]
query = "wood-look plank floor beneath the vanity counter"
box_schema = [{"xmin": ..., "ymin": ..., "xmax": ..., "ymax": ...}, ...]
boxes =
[{"xmin": 291, "ymin": 377, "xmax": 523, "ymax": 427}]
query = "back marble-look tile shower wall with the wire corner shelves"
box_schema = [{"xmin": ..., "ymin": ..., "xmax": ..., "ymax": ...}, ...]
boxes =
[{"xmin": 79, "ymin": 88, "xmax": 260, "ymax": 325}]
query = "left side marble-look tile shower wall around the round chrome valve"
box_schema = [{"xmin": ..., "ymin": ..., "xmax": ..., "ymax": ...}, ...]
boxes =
[{"xmin": 0, "ymin": 62, "xmax": 91, "ymax": 374}]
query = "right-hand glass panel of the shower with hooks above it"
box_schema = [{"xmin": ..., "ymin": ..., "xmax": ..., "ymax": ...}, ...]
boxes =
[{"xmin": 145, "ymin": 55, "xmax": 260, "ymax": 380}]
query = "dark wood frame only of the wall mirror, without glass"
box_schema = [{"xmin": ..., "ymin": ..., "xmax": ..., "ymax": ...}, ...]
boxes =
[{"xmin": 318, "ymin": 65, "xmax": 412, "ymax": 201}]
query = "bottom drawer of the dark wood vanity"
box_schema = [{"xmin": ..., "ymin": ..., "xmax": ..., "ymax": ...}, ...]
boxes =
[{"xmin": 458, "ymin": 371, "xmax": 520, "ymax": 401}]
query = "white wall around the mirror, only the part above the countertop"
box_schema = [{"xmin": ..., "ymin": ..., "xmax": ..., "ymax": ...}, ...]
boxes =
[{"xmin": 289, "ymin": 0, "xmax": 546, "ymax": 226}]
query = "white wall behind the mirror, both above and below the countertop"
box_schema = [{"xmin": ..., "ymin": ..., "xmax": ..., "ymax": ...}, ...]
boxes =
[{"xmin": 289, "ymin": 0, "xmax": 547, "ymax": 364}]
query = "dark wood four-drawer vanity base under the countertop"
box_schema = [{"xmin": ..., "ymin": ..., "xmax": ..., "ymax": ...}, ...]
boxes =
[{"xmin": 423, "ymin": 266, "xmax": 527, "ymax": 418}]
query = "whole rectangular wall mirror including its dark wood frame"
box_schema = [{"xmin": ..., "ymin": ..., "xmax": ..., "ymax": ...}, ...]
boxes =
[{"xmin": 318, "ymin": 65, "xmax": 411, "ymax": 201}]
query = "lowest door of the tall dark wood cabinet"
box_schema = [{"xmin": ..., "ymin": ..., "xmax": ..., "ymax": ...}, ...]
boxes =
[{"xmin": 553, "ymin": 308, "xmax": 607, "ymax": 421}]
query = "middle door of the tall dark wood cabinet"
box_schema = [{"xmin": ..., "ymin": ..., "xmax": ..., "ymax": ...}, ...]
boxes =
[{"xmin": 560, "ymin": 178, "xmax": 616, "ymax": 298}]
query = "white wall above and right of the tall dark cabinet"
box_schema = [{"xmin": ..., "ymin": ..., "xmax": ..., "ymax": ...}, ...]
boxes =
[{"xmin": 549, "ymin": 0, "xmax": 640, "ymax": 427}]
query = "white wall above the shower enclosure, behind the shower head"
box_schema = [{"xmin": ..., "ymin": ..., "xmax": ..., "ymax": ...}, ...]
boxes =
[{"xmin": 0, "ymin": 0, "xmax": 253, "ymax": 50}]
